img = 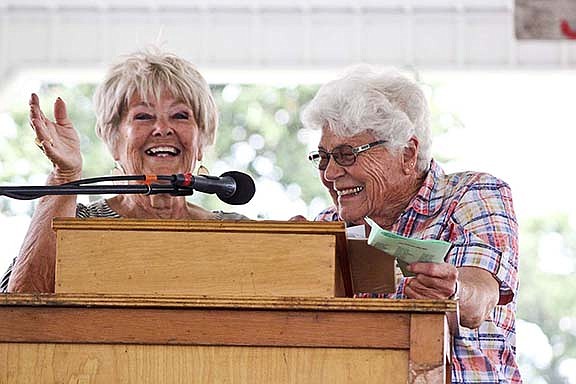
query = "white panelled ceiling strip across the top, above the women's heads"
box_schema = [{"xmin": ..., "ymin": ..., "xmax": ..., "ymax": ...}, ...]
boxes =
[{"xmin": 0, "ymin": 0, "xmax": 576, "ymax": 87}]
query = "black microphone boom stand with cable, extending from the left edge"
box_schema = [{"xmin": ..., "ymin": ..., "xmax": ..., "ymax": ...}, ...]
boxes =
[{"xmin": 0, "ymin": 175, "xmax": 194, "ymax": 200}]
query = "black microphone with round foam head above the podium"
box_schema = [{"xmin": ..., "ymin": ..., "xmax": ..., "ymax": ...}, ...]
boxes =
[{"xmin": 171, "ymin": 171, "xmax": 256, "ymax": 205}]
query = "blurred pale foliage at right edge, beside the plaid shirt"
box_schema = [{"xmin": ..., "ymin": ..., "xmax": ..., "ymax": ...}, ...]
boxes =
[{"xmin": 518, "ymin": 215, "xmax": 576, "ymax": 384}]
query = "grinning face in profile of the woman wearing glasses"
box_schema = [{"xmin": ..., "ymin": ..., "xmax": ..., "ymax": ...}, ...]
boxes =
[{"xmin": 318, "ymin": 129, "xmax": 417, "ymax": 224}]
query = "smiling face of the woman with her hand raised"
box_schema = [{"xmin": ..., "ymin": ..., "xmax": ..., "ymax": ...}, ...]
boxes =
[{"xmin": 114, "ymin": 92, "xmax": 202, "ymax": 174}]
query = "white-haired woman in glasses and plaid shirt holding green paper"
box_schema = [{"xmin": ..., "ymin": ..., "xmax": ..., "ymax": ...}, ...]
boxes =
[{"xmin": 302, "ymin": 67, "xmax": 521, "ymax": 384}]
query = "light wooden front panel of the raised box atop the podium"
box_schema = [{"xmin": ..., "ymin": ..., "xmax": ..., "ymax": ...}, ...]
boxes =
[{"xmin": 56, "ymin": 230, "xmax": 344, "ymax": 297}]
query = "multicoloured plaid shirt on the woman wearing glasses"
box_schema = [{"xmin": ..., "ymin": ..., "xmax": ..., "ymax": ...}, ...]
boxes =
[{"xmin": 316, "ymin": 160, "xmax": 522, "ymax": 384}]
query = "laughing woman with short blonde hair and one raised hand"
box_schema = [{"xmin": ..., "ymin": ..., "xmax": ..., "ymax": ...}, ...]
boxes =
[{"xmin": 0, "ymin": 50, "xmax": 246, "ymax": 292}]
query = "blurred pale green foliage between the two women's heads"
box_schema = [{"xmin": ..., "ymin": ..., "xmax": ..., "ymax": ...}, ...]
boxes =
[{"xmin": 200, "ymin": 84, "xmax": 329, "ymax": 214}]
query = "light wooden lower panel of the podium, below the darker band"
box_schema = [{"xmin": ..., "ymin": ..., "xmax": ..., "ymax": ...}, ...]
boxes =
[{"xmin": 0, "ymin": 344, "xmax": 407, "ymax": 384}]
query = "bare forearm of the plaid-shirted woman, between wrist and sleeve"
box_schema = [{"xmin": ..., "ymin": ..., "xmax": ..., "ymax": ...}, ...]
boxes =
[{"xmin": 458, "ymin": 267, "xmax": 499, "ymax": 329}]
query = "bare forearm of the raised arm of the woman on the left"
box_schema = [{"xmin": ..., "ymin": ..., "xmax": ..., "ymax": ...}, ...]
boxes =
[{"xmin": 8, "ymin": 173, "xmax": 80, "ymax": 292}]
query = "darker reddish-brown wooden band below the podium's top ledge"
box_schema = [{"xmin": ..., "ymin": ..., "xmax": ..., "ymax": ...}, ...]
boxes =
[{"xmin": 0, "ymin": 307, "xmax": 410, "ymax": 349}]
